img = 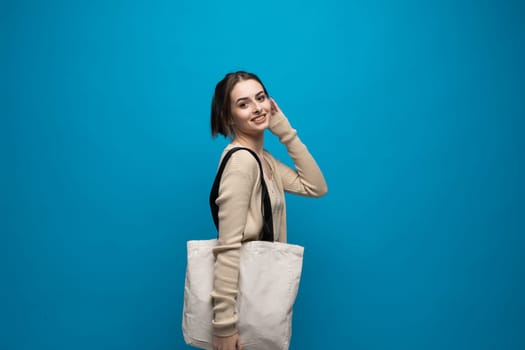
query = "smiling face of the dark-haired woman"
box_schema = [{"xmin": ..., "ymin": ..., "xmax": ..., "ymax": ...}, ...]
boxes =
[{"xmin": 230, "ymin": 79, "xmax": 272, "ymax": 136}]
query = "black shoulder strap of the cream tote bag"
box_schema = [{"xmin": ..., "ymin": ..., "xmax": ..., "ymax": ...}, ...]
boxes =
[{"xmin": 210, "ymin": 147, "xmax": 273, "ymax": 242}]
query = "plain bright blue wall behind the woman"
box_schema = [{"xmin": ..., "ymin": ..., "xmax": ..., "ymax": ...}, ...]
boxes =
[{"xmin": 0, "ymin": 0, "xmax": 525, "ymax": 350}]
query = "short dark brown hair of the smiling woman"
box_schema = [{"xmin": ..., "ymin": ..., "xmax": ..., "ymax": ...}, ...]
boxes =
[{"xmin": 211, "ymin": 71, "xmax": 268, "ymax": 137}]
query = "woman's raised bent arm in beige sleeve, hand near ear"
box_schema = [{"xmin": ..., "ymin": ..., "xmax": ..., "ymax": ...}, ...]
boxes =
[{"xmin": 269, "ymin": 99, "xmax": 328, "ymax": 197}]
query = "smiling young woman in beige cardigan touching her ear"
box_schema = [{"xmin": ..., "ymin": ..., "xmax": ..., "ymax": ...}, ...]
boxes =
[{"xmin": 211, "ymin": 71, "xmax": 327, "ymax": 350}]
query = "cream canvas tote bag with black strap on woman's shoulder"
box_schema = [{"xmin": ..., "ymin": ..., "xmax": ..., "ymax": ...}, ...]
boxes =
[{"xmin": 182, "ymin": 147, "xmax": 304, "ymax": 350}]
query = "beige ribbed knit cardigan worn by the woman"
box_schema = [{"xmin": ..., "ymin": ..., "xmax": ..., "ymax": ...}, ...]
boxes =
[{"xmin": 211, "ymin": 112, "xmax": 327, "ymax": 336}]
